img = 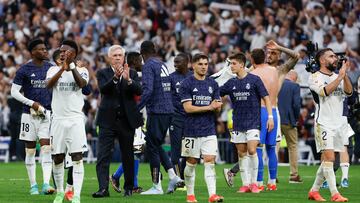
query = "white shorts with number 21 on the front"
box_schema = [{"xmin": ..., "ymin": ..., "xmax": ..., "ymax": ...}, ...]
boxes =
[{"xmin": 181, "ymin": 135, "xmax": 218, "ymax": 158}]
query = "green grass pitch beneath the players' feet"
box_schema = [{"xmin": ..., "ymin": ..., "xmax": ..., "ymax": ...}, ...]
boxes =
[{"xmin": 0, "ymin": 162, "xmax": 360, "ymax": 203}]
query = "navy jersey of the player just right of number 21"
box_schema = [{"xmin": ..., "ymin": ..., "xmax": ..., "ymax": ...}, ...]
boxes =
[{"xmin": 220, "ymin": 73, "xmax": 269, "ymax": 131}]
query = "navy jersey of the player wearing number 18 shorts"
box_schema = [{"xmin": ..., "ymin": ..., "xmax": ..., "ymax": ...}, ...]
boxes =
[{"xmin": 13, "ymin": 61, "xmax": 52, "ymax": 113}]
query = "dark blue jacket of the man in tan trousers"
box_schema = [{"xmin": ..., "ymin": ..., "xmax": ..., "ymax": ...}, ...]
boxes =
[{"xmin": 278, "ymin": 79, "xmax": 301, "ymax": 126}]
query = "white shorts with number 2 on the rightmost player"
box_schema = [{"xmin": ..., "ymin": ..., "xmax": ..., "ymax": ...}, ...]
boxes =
[{"xmin": 314, "ymin": 123, "xmax": 344, "ymax": 152}]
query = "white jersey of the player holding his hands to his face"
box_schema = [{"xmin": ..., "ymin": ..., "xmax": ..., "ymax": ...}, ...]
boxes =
[{"xmin": 46, "ymin": 66, "xmax": 89, "ymax": 119}]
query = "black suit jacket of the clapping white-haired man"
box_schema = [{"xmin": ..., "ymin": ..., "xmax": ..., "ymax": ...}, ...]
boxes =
[{"xmin": 96, "ymin": 67, "xmax": 143, "ymax": 129}]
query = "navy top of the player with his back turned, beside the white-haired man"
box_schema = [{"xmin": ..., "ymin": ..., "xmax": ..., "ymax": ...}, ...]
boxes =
[{"xmin": 138, "ymin": 58, "xmax": 174, "ymax": 114}]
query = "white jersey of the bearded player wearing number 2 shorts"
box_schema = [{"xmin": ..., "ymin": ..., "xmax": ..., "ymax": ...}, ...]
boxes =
[{"xmin": 309, "ymin": 71, "xmax": 346, "ymax": 129}]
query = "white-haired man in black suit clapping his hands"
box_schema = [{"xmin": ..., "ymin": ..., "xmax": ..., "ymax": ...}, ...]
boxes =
[{"xmin": 93, "ymin": 45, "xmax": 143, "ymax": 198}]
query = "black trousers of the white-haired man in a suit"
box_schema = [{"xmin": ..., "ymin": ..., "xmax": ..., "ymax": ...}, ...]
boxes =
[{"xmin": 96, "ymin": 118, "xmax": 135, "ymax": 190}]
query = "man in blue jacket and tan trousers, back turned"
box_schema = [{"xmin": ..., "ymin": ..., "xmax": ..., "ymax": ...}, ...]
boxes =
[{"xmin": 278, "ymin": 70, "xmax": 302, "ymax": 183}]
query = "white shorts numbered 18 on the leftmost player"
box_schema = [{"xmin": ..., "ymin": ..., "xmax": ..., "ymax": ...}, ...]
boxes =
[{"xmin": 19, "ymin": 111, "xmax": 50, "ymax": 141}]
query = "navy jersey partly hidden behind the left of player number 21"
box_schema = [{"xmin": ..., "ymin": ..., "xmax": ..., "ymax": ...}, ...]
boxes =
[{"xmin": 170, "ymin": 71, "xmax": 193, "ymax": 115}]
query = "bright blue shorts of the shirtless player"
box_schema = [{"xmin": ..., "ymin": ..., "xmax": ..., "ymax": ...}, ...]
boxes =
[{"xmin": 260, "ymin": 107, "xmax": 278, "ymax": 145}]
